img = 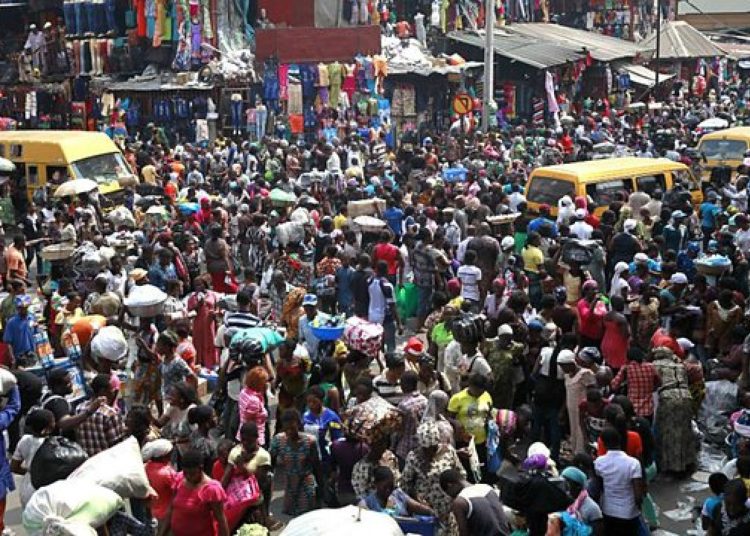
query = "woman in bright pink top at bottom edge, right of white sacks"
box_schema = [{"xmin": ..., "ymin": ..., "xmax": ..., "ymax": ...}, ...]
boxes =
[{"xmin": 159, "ymin": 450, "xmax": 229, "ymax": 536}]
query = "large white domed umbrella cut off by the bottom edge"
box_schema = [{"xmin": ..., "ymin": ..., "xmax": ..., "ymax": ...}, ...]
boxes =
[{"xmin": 281, "ymin": 506, "xmax": 404, "ymax": 536}]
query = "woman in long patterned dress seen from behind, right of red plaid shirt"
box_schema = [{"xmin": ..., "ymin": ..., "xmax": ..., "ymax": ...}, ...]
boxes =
[{"xmin": 651, "ymin": 347, "xmax": 697, "ymax": 473}]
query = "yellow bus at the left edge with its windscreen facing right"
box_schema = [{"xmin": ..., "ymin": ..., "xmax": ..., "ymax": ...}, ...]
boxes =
[{"xmin": 0, "ymin": 130, "xmax": 132, "ymax": 199}]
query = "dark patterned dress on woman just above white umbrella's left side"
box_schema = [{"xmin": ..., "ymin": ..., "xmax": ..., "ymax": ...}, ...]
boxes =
[{"xmin": 269, "ymin": 433, "xmax": 319, "ymax": 516}]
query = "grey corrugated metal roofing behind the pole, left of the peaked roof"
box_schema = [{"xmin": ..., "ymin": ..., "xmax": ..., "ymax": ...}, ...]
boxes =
[{"xmin": 448, "ymin": 23, "xmax": 644, "ymax": 69}]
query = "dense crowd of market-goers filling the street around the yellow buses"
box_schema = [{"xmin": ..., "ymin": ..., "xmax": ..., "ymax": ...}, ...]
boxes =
[{"xmin": 0, "ymin": 86, "xmax": 750, "ymax": 536}]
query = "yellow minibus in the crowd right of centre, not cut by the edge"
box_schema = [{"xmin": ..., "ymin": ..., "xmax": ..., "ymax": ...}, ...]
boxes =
[{"xmin": 526, "ymin": 157, "xmax": 703, "ymax": 216}]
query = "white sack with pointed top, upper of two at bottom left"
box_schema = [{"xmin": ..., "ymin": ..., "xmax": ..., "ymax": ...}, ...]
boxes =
[{"xmin": 68, "ymin": 436, "xmax": 150, "ymax": 499}]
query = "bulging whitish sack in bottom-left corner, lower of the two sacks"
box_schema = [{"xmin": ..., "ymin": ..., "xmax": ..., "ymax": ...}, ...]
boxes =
[{"xmin": 23, "ymin": 480, "xmax": 123, "ymax": 536}]
